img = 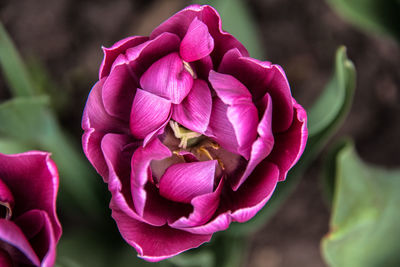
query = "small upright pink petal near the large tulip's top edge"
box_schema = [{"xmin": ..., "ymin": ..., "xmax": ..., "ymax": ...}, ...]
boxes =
[{"xmin": 179, "ymin": 17, "xmax": 214, "ymax": 62}]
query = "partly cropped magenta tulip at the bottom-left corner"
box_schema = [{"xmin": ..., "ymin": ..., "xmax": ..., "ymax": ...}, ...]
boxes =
[{"xmin": 0, "ymin": 151, "xmax": 61, "ymax": 267}]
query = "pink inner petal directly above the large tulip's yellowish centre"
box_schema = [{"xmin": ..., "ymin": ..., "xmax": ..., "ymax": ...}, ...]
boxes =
[{"xmin": 172, "ymin": 79, "xmax": 212, "ymax": 133}]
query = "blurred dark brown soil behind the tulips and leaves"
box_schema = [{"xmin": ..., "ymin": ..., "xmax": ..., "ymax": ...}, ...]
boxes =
[{"xmin": 0, "ymin": 0, "xmax": 400, "ymax": 267}]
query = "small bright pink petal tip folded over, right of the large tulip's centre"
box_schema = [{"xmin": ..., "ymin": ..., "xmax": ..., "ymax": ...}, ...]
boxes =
[{"xmin": 208, "ymin": 70, "xmax": 252, "ymax": 105}]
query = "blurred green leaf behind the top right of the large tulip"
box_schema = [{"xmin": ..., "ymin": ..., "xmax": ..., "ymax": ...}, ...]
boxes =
[{"xmin": 193, "ymin": 0, "xmax": 265, "ymax": 60}]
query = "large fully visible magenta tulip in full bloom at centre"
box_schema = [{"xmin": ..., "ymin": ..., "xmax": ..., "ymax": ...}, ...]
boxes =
[{"xmin": 82, "ymin": 5, "xmax": 307, "ymax": 261}]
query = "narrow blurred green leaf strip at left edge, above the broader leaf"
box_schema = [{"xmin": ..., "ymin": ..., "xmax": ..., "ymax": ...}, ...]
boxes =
[{"xmin": 0, "ymin": 22, "xmax": 35, "ymax": 96}]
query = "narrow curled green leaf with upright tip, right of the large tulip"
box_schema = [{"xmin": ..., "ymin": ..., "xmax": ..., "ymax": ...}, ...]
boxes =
[{"xmin": 226, "ymin": 47, "xmax": 356, "ymax": 235}]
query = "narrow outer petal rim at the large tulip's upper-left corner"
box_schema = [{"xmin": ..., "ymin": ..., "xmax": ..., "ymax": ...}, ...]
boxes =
[{"xmin": 99, "ymin": 36, "xmax": 149, "ymax": 80}]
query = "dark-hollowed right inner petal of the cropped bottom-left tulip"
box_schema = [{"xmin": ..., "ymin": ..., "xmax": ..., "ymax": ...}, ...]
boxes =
[{"xmin": 15, "ymin": 210, "xmax": 57, "ymax": 267}]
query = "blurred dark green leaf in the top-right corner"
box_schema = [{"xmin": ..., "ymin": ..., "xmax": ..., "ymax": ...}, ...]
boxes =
[{"xmin": 327, "ymin": 0, "xmax": 400, "ymax": 41}]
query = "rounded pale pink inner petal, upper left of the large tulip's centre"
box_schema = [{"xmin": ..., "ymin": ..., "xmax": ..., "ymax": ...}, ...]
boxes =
[{"xmin": 140, "ymin": 53, "xmax": 193, "ymax": 104}]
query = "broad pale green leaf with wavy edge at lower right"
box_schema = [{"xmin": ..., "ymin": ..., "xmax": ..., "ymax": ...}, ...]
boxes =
[{"xmin": 322, "ymin": 142, "xmax": 400, "ymax": 267}]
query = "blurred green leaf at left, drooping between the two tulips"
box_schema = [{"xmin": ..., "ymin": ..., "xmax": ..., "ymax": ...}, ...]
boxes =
[{"xmin": 0, "ymin": 96, "xmax": 99, "ymax": 219}]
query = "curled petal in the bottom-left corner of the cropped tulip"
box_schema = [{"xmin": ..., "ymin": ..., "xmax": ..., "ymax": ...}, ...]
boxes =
[{"xmin": 0, "ymin": 219, "xmax": 40, "ymax": 266}]
